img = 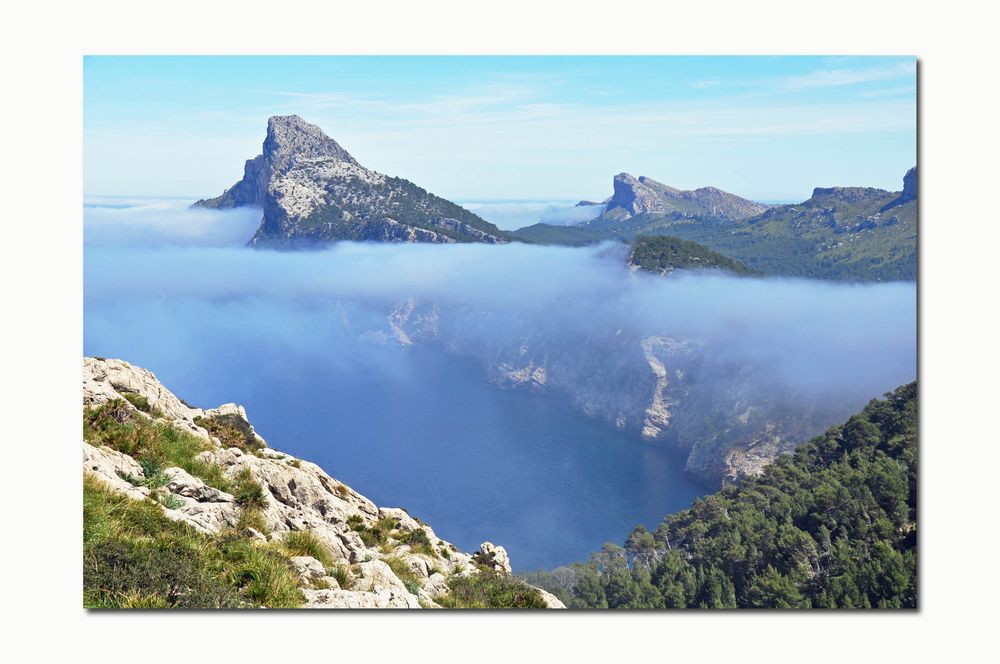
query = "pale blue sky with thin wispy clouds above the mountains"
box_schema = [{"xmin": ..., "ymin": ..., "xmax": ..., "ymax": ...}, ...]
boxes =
[{"xmin": 84, "ymin": 56, "xmax": 916, "ymax": 200}]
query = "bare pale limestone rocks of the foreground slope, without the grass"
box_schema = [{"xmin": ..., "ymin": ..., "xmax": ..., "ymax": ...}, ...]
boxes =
[{"xmin": 83, "ymin": 357, "xmax": 563, "ymax": 609}]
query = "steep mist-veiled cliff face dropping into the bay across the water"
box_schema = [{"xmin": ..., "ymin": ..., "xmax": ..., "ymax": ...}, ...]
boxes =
[{"xmin": 384, "ymin": 299, "xmax": 855, "ymax": 483}]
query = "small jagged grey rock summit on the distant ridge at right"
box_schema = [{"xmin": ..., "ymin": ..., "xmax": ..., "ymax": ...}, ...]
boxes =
[{"xmin": 605, "ymin": 173, "xmax": 767, "ymax": 221}]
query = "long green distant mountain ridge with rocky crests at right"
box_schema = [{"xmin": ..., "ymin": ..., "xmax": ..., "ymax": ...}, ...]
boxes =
[{"xmin": 512, "ymin": 167, "xmax": 917, "ymax": 281}]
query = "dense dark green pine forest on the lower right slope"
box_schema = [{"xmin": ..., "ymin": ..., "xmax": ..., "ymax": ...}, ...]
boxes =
[{"xmin": 526, "ymin": 383, "xmax": 917, "ymax": 608}]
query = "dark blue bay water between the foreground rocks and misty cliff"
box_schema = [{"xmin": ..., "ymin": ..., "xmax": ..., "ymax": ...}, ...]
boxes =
[{"xmin": 85, "ymin": 332, "xmax": 711, "ymax": 570}]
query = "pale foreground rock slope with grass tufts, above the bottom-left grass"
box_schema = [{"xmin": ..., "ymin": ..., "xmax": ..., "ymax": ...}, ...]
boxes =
[{"xmin": 83, "ymin": 358, "xmax": 562, "ymax": 608}]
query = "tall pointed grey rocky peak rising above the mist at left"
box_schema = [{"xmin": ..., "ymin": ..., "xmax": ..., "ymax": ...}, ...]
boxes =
[{"xmin": 195, "ymin": 115, "xmax": 507, "ymax": 248}]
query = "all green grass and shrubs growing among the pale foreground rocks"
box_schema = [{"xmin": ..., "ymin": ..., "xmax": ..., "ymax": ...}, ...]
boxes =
[{"xmin": 83, "ymin": 399, "xmax": 545, "ymax": 609}]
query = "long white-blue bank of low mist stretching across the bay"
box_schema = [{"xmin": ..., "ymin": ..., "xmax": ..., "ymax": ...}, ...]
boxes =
[{"xmin": 84, "ymin": 202, "xmax": 916, "ymax": 448}]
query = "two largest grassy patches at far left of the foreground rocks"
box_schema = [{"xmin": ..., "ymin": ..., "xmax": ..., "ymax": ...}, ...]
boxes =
[{"xmin": 83, "ymin": 400, "xmax": 312, "ymax": 608}]
